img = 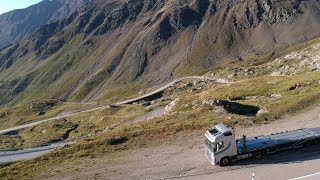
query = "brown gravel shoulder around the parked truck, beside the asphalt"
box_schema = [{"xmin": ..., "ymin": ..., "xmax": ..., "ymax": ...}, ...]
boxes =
[{"xmin": 42, "ymin": 105, "xmax": 320, "ymax": 179}]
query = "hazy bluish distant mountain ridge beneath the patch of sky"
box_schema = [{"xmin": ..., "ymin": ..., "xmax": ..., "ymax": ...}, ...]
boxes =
[{"xmin": 0, "ymin": 0, "xmax": 90, "ymax": 48}]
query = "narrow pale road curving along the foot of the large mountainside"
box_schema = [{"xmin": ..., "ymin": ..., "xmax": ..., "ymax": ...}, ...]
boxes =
[{"xmin": 0, "ymin": 76, "xmax": 214, "ymax": 134}]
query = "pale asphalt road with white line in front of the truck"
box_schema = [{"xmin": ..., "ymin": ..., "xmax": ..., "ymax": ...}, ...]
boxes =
[{"xmin": 172, "ymin": 154, "xmax": 320, "ymax": 180}]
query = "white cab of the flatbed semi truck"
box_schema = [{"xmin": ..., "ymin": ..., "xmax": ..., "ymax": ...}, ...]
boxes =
[{"xmin": 205, "ymin": 123, "xmax": 237, "ymax": 166}]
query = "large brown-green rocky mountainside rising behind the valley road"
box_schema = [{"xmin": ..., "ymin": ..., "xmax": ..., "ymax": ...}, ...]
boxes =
[{"xmin": 0, "ymin": 0, "xmax": 320, "ymax": 104}]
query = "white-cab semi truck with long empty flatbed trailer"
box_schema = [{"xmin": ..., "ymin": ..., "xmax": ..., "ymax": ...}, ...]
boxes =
[{"xmin": 205, "ymin": 123, "xmax": 320, "ymax": 166}]
